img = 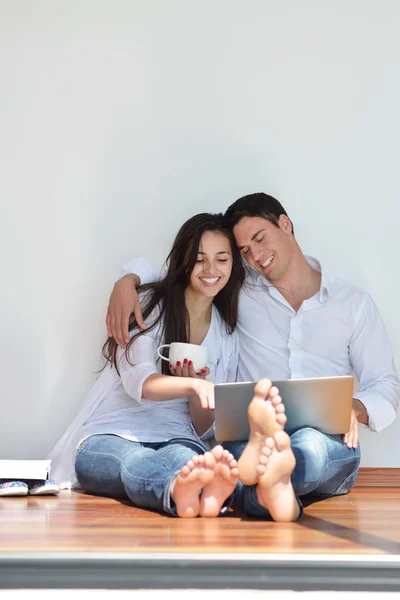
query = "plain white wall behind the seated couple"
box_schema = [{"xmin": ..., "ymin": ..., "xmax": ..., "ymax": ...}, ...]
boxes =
[{"xmin": 0, "ymin": 0, "xmax": 400, "ymax": 466}]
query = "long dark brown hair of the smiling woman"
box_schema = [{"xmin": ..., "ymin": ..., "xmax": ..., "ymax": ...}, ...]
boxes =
[{"xmin": 103, "ymin": 213, "xmax": 245, "ymax": 375}]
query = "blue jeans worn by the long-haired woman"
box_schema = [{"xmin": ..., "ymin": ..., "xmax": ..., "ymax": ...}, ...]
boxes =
[{"xmin": 75, "ymin": 434, "xmax": 205, "ymax": 516}]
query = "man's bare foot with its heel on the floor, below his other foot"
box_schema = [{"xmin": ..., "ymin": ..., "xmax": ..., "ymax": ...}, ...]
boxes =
[{"xmin": 256, "ymin": 431, "xmax": 300, "ymax": 521}]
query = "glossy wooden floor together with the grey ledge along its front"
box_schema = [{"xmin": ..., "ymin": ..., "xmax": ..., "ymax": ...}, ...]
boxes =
[{"xmin": 0, "ymin": 469, "xmax": 400, "ymax": 592}]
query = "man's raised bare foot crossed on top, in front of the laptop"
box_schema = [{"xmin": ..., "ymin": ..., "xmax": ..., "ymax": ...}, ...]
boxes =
[{"xmin": 238, "ymin": 379, "xmax": 286, "ymax": 485}]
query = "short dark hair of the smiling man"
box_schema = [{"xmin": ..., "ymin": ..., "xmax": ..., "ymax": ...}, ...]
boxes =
[{"xmin": 224, "ymin": 192, "xmax": 293, "ymax": 233}]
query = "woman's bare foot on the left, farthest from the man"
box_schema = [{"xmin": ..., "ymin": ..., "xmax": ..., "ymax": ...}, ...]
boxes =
[{"xmin": 171, "ymin": 452, "xmax": 215, "ymax": 519}]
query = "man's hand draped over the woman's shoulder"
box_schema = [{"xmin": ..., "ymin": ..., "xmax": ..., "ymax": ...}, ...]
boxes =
[{"xmin": 106, "ymin": 275, "xmax": 146, "ymax": 348}]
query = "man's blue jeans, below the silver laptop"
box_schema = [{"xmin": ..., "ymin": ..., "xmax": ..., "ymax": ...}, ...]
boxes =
[{"xmin": 222, "ymin": 427, "xmax": 360, "ymax": 517}]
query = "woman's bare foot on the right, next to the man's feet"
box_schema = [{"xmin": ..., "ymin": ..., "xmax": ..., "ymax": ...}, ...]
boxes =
[{"xmin": 200, "ymin": 446, "xmax": 239, "ymax": 517}]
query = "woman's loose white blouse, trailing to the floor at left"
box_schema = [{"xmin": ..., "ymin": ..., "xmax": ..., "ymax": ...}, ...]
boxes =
[{"xmin": 49, "ymin": 305, "xmax": 238, "ymax": 488}]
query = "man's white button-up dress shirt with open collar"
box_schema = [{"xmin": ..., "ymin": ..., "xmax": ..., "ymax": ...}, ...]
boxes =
[{"xmin": 123, "ymin": 257, "xmax": 400, "ymax": 431}]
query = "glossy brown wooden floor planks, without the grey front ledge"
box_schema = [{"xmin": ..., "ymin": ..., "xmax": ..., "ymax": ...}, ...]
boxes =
[{"xmin": 0, "ymin": 469, "xmax": 400, "ymax": 555}]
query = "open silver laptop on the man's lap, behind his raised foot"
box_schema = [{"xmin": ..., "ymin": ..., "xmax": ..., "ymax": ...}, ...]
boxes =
[{"xmin": 215, "ymin": 375, "xmax": 354, "ymax": 442}]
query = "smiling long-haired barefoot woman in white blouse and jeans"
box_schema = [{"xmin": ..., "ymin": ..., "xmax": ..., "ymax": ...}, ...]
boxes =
[{"xmin": 51, "ymin": 213, "xmax": 244, "ymax": 517}]
